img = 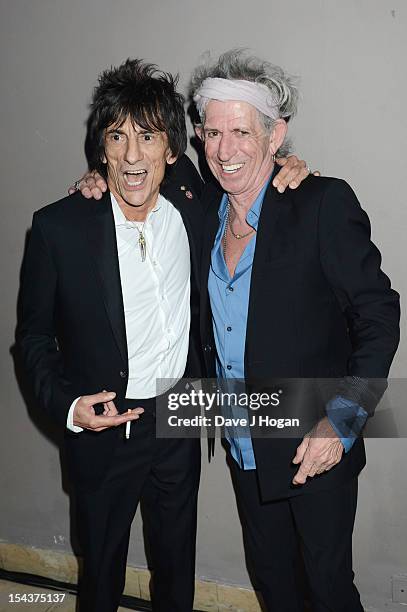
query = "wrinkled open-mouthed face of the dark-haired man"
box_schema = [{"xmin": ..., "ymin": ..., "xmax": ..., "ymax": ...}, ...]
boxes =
[{"xmin": 103, "ymin": 117, "xmax": 176, "ymax": 212}]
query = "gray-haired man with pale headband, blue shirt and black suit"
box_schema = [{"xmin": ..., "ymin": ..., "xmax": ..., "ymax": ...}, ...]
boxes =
[{"xmin": 192, "ymin": 51, "xmax": 399, "ymax": 612}]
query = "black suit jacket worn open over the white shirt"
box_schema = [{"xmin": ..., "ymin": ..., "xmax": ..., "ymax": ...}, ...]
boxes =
[{"xmin": 17, "ymin": 156, "xmax": 203, "ymax": 484}]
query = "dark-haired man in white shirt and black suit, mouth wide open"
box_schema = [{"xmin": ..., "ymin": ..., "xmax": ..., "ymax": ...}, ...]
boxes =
[{"xmin": 17, "ymin": 60, "xmax": 207, "ymax": 612}]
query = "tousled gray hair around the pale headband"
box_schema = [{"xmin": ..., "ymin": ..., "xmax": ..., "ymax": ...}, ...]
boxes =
[{"xmin": 190, "ymin": 49, "xmax": 299, "ymax": 156}]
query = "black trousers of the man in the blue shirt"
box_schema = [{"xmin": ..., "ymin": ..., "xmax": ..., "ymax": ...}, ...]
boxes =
[{"xmin": 228, "ymin": 454, "xmax": 363, "ymax": 612}]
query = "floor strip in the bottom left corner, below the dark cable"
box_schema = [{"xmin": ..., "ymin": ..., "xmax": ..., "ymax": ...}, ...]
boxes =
[{"xmin": 0, "ymin": 580, "xmax": 139, "ymax": 612}]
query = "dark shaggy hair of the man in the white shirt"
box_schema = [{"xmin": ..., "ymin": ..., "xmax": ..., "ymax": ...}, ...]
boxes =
[{"xmin": 85, "ymin": 59, "xmax": 187, "ymax": 177}]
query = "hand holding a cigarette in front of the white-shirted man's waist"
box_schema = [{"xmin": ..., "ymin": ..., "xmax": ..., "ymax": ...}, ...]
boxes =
[{"xmin": 73, "ymin": 391, "xmax": 144, "ymax": 431}]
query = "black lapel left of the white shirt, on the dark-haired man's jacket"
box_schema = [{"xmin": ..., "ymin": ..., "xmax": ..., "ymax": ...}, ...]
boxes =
[{"xmin": 87, "ymin": 191, "xmax": 128, "ymax": 367}]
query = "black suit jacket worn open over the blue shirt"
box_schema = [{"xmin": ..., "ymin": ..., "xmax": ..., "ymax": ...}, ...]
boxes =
[{"xmin": 201, "ymin": 176, "xmax": 399, "ymax": 500}]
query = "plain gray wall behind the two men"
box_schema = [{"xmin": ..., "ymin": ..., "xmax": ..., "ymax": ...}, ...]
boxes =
[{"xmin": 0, "ymin": 0, "xmax": 407, "ymax": 608}]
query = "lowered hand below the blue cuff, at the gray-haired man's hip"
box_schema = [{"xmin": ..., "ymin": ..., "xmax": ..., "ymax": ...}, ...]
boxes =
[{"xmin": 293, "ymin": 417, "xmax": 343, "ymax": 484}]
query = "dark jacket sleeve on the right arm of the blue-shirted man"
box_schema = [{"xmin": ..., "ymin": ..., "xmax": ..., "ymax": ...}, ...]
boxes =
[{"xmin": 319, "ymin": 180, "xmax": 400, "ymax": 416}]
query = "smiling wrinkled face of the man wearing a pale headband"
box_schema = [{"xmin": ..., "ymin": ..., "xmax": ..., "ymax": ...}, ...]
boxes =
[{"xmin": 202, "ymin": 100, "xmax": 278, "ymax": 196}]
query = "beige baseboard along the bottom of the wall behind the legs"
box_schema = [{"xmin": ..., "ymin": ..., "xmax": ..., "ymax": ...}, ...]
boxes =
[{"xmin": 0, "ymin": 542, "xmax": 261, "ymax": 612}]
